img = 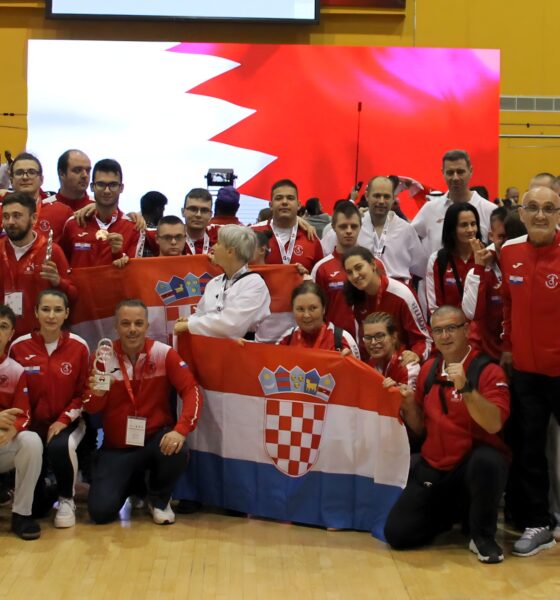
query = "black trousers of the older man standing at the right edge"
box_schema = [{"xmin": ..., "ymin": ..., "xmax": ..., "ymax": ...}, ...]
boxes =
[{"xmin": 507, "ymin": 370, "xmax": 560, "ymax": 527}]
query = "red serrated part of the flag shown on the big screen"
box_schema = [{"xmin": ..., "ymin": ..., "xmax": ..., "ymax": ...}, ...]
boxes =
[{"xmin": 172, "ymin": 44, "xmax": 499, "ymax": 207}]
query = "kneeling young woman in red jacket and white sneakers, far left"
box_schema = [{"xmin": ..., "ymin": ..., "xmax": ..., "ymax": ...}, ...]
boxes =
[{"xmin": 10, "ymin": 289, "xmax": 89, "ymax": 528}]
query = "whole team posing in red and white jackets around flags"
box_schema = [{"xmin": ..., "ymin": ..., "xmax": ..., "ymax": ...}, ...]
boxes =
[{"xmin": 0, "ymin": 145, "xmax": 560, "ymax": 563}]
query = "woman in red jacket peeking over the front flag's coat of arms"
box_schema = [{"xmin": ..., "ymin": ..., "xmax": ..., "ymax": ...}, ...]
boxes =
[{"xmin": 278, "ymin": 280, "xmax": 360, "ymax": 360}]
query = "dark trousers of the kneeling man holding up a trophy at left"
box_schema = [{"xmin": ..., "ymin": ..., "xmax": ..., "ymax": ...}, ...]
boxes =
[{"xmin": 88, "ymin": 430, "xmax": 188, "ymax": 523}]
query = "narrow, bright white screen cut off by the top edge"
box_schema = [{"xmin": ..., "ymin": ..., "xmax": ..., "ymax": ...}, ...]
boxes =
[{"xmin": 47, "ymin": 0, "xmax": 319, "ymax": 22}]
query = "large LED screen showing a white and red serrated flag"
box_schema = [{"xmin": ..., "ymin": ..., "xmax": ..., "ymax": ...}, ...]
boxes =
[{"xmin": 28, "ymin": 40, "xmax": 499, "ymax": 222}]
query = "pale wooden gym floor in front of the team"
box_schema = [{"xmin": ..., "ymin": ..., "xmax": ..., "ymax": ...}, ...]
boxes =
[{"xmin": 0, "ymin": 504, "xmax": 560, "ymax": 600}]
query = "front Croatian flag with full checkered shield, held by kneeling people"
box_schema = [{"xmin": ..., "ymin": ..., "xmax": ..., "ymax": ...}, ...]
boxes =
[{"xmin": 175, "ymin": 334, "xmax": 410, "ymax": 539}]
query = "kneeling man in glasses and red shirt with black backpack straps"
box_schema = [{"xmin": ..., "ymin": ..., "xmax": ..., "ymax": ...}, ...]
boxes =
[{"xmin": 385, "ymin": 306, "xmax": 509, "ymax": 563}]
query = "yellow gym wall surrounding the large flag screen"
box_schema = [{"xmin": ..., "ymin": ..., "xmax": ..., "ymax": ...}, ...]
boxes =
[{"xmin": 0, "ymin": 0, "xmax": 560, "ymax": 191}]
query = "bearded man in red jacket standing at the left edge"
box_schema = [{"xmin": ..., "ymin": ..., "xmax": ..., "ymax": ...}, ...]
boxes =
[{"xmin": 0, "ymin": 192, "xmax": 78, "ymax": 337}]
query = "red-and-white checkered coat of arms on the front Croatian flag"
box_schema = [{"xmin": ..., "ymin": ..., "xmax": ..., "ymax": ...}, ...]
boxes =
[{"xmin": 259, "ymin": 367, "xmax": 336, "ymax": 477}]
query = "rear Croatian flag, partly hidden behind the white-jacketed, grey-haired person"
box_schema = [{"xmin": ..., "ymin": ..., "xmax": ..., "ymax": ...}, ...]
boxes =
[{"xmin": 71, "ymin": 255, "xmax": 301, "ymax": 349}]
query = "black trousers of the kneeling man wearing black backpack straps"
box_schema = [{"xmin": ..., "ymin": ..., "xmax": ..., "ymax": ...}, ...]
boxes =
[{"xmin": 385, "ymin": 446, "xmax": 508, "ymax": 550}]
